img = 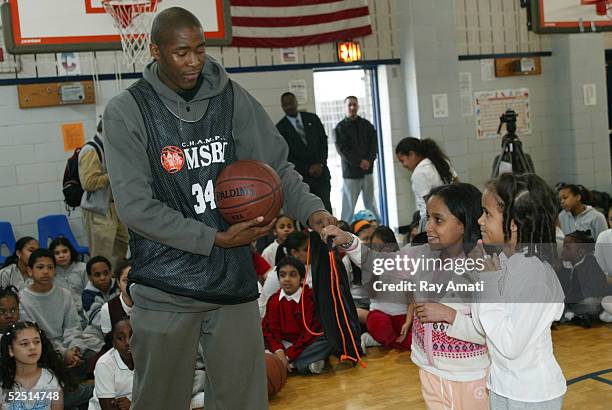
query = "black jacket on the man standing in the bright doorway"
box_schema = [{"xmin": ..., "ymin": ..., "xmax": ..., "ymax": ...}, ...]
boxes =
[{"xmin": 334, "ymin": 116, "xmax": 378, "ymax": 179}]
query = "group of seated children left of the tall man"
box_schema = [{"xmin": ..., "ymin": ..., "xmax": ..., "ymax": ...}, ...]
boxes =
[{"xmin": 0, "ymin": 237, "xmax": 204, "ymax": 410}]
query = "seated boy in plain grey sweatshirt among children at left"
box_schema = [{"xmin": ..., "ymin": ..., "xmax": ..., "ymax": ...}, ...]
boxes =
[{"xmin": 19, "ymin": 248, "xmax": 86, "ymax": 368}]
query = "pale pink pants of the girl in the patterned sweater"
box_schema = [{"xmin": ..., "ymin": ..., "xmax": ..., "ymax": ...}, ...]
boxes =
[{"xmin": 419, "ymin": 369, "xmax": 489, "ymax": 410}]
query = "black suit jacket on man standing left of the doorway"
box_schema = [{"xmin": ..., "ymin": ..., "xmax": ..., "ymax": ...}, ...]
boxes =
[{"xmin": 276, "ymin": 112, "xmax": 330, "ymax": 186}]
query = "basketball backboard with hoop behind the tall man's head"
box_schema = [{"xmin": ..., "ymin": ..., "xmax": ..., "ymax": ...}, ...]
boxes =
[{"xmin": 2, "ymin": 0, "xmax": 231, "ymax": 54}]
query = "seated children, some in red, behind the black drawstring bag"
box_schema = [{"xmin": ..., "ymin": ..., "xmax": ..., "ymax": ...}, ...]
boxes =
[{"xmin": 253, "ymin": 211, "xmax": 413, "ymax": 373}]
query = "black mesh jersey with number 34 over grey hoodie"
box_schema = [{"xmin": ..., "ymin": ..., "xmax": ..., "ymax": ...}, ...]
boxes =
[{"xmin": 128, "ymin": 79, "xmax": 258, "ymax": 304}]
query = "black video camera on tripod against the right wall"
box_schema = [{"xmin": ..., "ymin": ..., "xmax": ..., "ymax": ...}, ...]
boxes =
[{"xmin": 491, "ymin": 109, "xmax": 535, "ymax": 178}]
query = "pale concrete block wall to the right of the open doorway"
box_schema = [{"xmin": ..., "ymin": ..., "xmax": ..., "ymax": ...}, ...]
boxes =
[{"xmin": 396, "ymin": 0, "xmax": 610, "ymax": 205}]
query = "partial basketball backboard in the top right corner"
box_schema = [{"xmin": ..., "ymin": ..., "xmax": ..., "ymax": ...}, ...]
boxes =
[{"xmin": 531, "ymin": 0, "xmax": 612, "ymax": 34}]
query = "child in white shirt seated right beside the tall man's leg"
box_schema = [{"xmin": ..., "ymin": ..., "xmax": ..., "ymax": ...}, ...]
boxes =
[{"xmin": 89, "ymin": 317, "xmax": 134, "ymax": 410}]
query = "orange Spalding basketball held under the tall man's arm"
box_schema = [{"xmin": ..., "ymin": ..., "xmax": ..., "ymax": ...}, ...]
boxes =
[{"xmin": 215, "ymin": 160, "xmax": 283, "ymax": 225}]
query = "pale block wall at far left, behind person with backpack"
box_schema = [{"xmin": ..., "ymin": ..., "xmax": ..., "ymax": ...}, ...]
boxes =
[{"xmin": 0, "ymin": 86, "xmax": 95, "ymax": 247}]
